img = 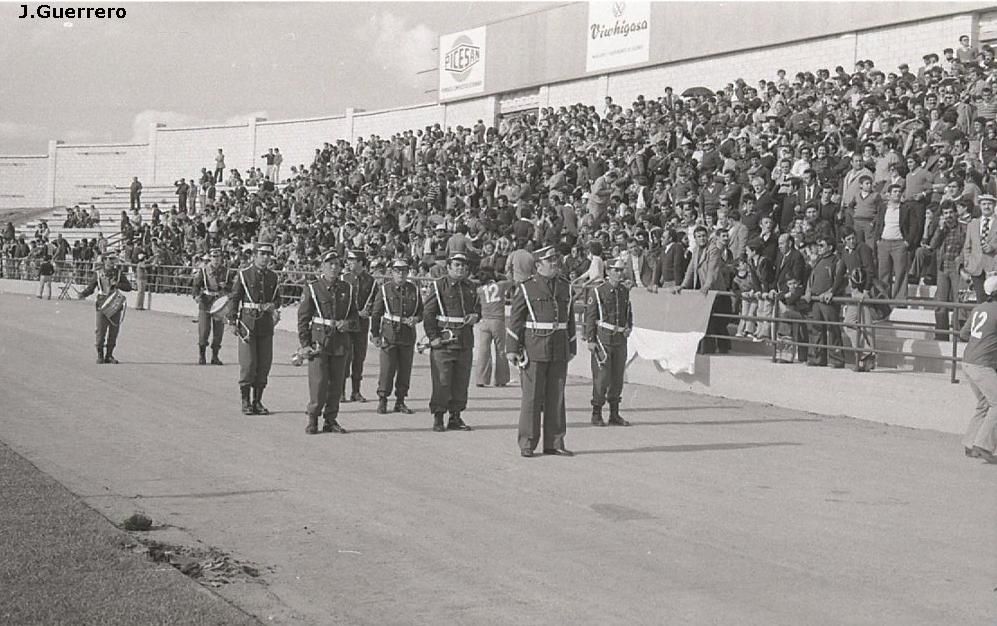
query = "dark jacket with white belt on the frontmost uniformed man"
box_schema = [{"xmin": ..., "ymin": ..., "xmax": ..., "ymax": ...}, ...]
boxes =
[{"xmin": 506, "ymin": 275, "xmax": 578, "ymax": 362}]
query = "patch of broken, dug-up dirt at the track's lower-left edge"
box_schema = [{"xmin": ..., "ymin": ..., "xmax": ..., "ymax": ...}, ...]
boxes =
[{"xmin": 125, "ymin": 538, "xmax": 274, "ymax": 588}]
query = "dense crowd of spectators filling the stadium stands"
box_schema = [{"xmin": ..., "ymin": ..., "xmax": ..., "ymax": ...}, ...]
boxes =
[{"xmin": 4, "ymin": 37, "xmax": 997, "ymax": 365}]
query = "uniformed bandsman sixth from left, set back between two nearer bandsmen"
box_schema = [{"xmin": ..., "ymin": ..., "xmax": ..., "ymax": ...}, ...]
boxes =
[{"xmin": 370, "ymin": 259, "xmax": 423, "ymax": 415}]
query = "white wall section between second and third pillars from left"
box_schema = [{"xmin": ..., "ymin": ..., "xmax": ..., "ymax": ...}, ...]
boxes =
[{"xmin": 154, "ymin": 124, "xmax": 253, "ymax": 185}]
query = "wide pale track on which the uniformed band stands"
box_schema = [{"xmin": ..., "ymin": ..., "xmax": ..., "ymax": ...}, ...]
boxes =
[{"xmin": 0, "ymin": 296, "xmax": 997, "ymax": 625}]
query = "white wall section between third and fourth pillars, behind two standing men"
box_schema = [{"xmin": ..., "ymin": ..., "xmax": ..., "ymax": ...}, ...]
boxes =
[{"xmin": 256, "ymin": 116, "xmax": 350, "ymax": 178}]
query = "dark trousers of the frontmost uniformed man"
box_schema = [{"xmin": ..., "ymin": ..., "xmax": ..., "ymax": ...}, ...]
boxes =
[{"xmin": 519, "ymin": 361, "xmax": 568, "ymax": 450}]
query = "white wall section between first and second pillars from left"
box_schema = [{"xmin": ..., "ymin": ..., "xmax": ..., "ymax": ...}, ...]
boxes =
[{"xmin": 55, "ymin": 144, "xmax": 148, "ymax": 205}]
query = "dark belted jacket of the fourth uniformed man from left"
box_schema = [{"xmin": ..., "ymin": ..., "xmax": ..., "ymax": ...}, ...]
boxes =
[{"xmin": 298, "ymin": 278, "xmax": 363, "ymax": 356}]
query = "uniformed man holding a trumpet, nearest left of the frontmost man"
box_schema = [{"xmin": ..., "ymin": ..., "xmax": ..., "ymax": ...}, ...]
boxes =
[{"xmin": 422, "ymin": 252, "xmax": 481, "ymax": 432}]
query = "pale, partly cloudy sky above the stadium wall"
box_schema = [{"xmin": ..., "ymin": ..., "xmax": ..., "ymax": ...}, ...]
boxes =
[{"xmin": 0, "ymin": 0, "xmax": 552, "ymax": 155}]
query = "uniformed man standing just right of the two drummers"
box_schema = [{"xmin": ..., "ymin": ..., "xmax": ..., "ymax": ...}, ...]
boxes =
[{"xmin": 228, "ymin": 242, "xmax": 280, "ymax": 415}]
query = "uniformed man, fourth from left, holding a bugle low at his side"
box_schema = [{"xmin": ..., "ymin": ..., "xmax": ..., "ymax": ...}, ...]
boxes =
[{"xmin": 298, "ymin": 250, "xmax": 365, "ymax": 435}]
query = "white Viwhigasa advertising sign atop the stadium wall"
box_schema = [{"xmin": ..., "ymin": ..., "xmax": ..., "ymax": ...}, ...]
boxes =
[{"xmin": 585, "ymin": 2, "xmax": 651, "ymax": 72}]
